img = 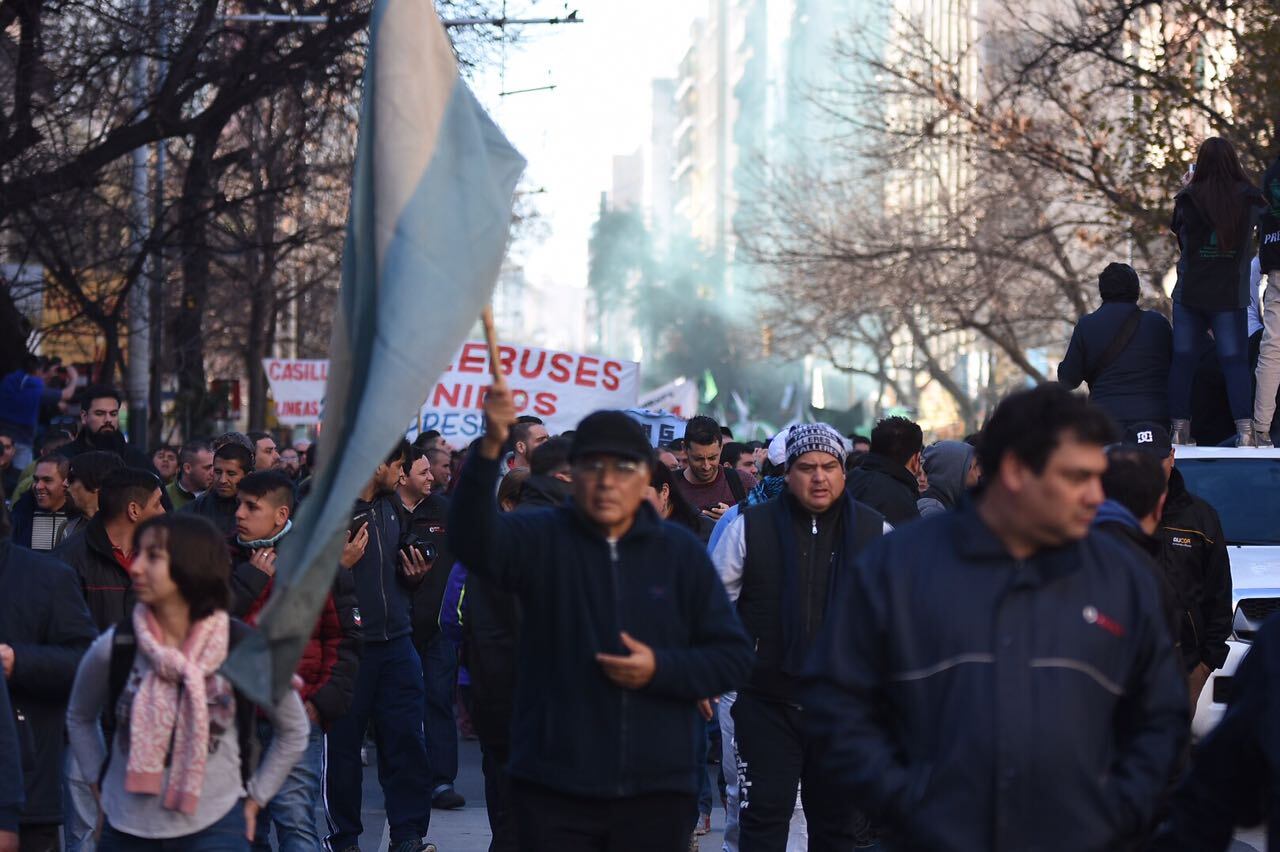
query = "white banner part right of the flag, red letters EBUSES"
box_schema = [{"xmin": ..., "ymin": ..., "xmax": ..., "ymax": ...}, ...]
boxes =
[{"xmin": 417, "ymin": 342, "xmax": 640, "ymax": 444}]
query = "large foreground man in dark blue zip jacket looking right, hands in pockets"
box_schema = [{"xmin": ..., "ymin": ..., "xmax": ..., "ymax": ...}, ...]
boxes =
[{"xmin": 801, "ymin": 384, "xmax": 1189, "ymax": 852}]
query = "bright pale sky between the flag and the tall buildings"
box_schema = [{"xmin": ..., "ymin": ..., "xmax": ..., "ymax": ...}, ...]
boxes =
[{"xmin": 474, "ymin": 0, "xmax": 707, "ymax": 318}]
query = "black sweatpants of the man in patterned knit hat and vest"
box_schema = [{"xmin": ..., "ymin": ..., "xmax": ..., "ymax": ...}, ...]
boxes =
[{"xmin": 730, "ymin": 692, "xmax": 861, "ymax": 852}]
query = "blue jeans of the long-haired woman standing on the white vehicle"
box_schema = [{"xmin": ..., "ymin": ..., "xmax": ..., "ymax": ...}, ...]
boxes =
[{"xmin": 1169, "ymin": 302, "xmax": 1253, "ymax": 420}]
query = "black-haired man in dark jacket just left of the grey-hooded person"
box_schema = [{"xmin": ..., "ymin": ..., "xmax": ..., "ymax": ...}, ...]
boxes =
[{"xmin": 849, "ymin": 417, "xmax": 924, "ymax": 527}]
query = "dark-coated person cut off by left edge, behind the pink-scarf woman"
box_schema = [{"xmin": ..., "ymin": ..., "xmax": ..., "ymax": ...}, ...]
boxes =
[{"xmin": 0, "ymin": 506, "xmax": 97, "ymax": 852}]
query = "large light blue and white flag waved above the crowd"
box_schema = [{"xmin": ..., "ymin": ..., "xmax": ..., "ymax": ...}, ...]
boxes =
[{"xmin": 224, "ymin": 0, "xmax": 525, "ymax": 704}]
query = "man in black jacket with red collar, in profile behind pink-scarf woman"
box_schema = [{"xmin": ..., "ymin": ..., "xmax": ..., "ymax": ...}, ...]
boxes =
[{"xmin": 54, "ymin": 467, "xmax": 164, "ymax": 632}]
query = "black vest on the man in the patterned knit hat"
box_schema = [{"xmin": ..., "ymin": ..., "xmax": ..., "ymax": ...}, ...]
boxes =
[{"xmin": 737, "ymin": 491, "xmax": 884, "ymax": 701}]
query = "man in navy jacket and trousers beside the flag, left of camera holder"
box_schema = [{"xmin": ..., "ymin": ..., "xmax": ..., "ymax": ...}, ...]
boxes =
[{"xmin": 325, "ymin": 441, "xmax": 431, "ymax": 852}]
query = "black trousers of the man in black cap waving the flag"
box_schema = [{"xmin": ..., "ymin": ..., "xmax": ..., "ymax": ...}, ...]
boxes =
[{"xmin": 511, "ymin": 778, "xmax": 698, "ymax": 852}]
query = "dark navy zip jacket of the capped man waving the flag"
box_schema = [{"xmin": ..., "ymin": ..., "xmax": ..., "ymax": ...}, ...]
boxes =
[{"xmin": 449, "ymin": 453, "xmax": 751, "ymax": 798}]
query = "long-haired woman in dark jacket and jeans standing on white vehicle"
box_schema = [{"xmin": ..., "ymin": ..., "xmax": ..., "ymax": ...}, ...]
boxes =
[{"xmin": 1169, "ymin": 137, "xmax": 1262, "ymax": 446}]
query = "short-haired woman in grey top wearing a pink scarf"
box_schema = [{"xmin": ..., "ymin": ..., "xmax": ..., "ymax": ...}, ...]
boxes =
[{"xmin": 67, "ymin": 514, "xmax": 310, "ymax": 852}]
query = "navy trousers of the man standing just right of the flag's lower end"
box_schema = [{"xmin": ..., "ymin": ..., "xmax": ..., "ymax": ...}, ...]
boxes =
[{"xmin": 325, "ymin": 636, "xmax": 431, "ymax": 849}]
